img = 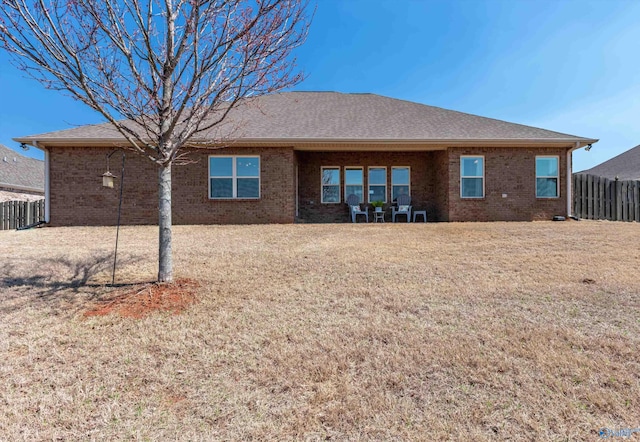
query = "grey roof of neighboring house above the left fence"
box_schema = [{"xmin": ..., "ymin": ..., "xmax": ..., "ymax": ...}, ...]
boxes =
[{"xmin": 0, "ymin": 144, "xmax": 44, "ymax": 192}]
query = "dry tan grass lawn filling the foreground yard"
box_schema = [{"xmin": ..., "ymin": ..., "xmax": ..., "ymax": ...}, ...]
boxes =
[{"xmin": 0, "ymin": 221, "xmax": 640, "ymax": 441}]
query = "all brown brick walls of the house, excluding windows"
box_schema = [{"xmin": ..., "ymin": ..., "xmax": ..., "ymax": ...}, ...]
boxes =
[{"xmin": 49, "ymin": 146, "xmax": 567, "ymax": 226}]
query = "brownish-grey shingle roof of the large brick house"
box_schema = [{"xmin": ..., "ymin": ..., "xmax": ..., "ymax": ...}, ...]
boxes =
[{"xmin": 16, "ymin": 92, "xmax": 597, "ymax": 145}]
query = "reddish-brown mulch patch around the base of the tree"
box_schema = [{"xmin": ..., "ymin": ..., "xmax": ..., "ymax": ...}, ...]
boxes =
[{"xmin": 83, "ymin": 278, "xmax": 200, "ymax": 319}]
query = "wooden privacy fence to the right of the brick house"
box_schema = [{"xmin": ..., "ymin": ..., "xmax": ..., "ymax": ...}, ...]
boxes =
[{"xmin": 573, "ymin": 174, "xmax": 640, "ymax": 221}]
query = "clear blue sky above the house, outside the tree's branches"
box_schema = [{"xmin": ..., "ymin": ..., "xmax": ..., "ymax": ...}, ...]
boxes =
[{"xmin": 0, "ymin": 0, "xmax": 640, "ymax": 171}]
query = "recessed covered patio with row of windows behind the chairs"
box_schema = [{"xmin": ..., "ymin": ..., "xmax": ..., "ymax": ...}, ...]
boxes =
[{"xmin": 296, "ymin": 146, "xmax": 449, "ymax": 223}]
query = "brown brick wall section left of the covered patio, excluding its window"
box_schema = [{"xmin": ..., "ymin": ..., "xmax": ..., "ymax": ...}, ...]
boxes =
[{"xmin": 49, "ymin": 147, "xmax": 295, "ymax": 226}]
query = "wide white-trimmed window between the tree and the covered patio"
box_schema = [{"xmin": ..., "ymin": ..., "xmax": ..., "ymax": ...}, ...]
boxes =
[{"xmin": 209, "ymin": 155, "xmax": 260, "ymax": 199}]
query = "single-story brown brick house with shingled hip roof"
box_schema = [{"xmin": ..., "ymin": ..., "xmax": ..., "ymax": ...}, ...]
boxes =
[{"xmin": 16, "ymin": 92, "xmax": 597, "ymax": 226}]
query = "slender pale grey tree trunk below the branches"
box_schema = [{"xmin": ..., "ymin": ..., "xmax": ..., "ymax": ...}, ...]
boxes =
[{"xmin": 158, "ymin": 163, "xmax": 173, "ymax": 282}]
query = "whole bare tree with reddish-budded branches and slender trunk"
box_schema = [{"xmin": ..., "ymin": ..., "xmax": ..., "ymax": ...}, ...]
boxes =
[{"xmin": 0, "ymin": 0, "xmax": 309, "ymax": 282}]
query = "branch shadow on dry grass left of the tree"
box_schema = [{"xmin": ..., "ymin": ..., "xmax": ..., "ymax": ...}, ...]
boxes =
[{"xmin": 0, "ymin": 253, "xmax": 149, "ymax": 315}]
